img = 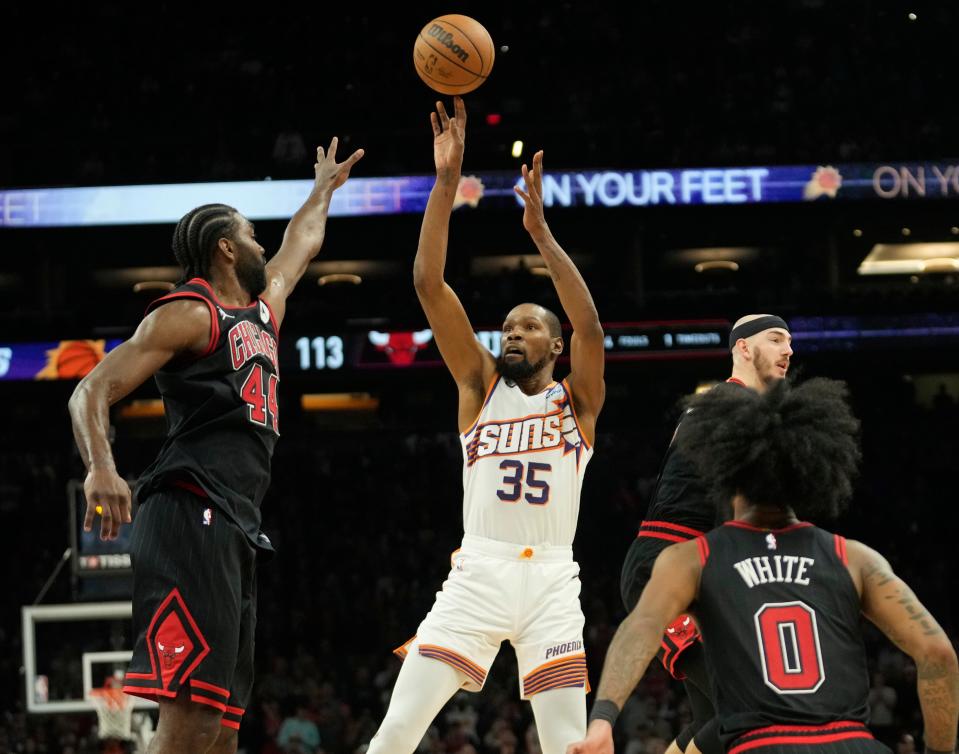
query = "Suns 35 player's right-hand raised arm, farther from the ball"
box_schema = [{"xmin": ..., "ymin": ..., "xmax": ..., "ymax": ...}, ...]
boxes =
[{"xmin": 514, "ymin": 150, "xmax": 606, "ymax": 444}]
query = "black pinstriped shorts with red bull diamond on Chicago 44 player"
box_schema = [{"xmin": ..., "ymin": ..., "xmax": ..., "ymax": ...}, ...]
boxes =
[{"xmin": 123, "ymin": 487, "xmax": 256, "ymax": 729}]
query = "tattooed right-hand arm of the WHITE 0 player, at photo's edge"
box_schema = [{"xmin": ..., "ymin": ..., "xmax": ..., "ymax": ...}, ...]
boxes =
[{"xmin": 846, "ymin": 540, "xmax": 959, "ymax": 752}]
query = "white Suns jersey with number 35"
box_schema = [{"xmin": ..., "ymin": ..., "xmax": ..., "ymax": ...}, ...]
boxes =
[{"xmin": 460, "ymin": 377, "xmax": 593, "ymax": 545}]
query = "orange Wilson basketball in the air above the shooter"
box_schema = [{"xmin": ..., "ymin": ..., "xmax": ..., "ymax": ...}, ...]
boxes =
[{"xmin": 413, "ymin": 14, "xmax": 496, "ymax": 94}]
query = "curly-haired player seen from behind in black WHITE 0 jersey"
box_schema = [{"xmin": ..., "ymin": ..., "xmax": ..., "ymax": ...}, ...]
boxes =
[{"xmin": 568, "ymin": 379, "xmax": 959, "ymax": 754}]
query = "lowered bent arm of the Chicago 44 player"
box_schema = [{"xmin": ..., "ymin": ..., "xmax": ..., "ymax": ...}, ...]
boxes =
[{"xmin": 69, "ymin": 300, "xmax": 210, "ymax": 539}]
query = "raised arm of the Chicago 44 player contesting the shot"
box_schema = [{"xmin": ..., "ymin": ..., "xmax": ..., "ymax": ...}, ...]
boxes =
[{"xmin": 263, "ymin": 136, "xmax": 363, "ymax": 325}]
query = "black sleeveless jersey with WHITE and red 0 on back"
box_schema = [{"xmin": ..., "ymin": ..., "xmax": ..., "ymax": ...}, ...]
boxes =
[{"xmin": 695, "ymin": 521, "xmax": 869, "ymax": 743}]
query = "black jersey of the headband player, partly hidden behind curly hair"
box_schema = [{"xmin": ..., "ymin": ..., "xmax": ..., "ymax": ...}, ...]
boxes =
[{"xmin": 637, "ymin": 380, "xmax": 744, "ymax": 548}]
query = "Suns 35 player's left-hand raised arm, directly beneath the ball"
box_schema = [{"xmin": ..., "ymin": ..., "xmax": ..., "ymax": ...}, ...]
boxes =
[{"xmin": 413, "ymin": 97, "xmax": 496, "ymax": 431}]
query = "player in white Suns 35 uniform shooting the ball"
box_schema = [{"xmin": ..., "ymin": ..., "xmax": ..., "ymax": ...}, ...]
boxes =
[{"xmin": 369, "ymin": 97, "xmax": 605, "ymax": 754}]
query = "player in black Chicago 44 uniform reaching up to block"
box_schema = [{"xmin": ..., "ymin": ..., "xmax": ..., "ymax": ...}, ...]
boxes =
[{"xmin": 70, "ymin": 139, "xmax": 363, "ymax": 754}]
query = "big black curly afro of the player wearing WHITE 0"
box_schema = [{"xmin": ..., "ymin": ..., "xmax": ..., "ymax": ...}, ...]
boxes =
[{"xmin": 676, "ymin": 378, "xmax": 862, "ymax": 520}]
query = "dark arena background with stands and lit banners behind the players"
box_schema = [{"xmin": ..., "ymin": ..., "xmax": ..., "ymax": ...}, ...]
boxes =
[{"xmin": 0, "ymin": 0, "xmax": 959, "ymax": 754}]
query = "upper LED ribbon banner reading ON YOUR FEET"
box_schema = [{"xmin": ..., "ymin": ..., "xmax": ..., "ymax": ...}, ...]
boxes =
[{"xmin": 0, "ymin": 160, "xmax": 959, "ymax": 228}]
